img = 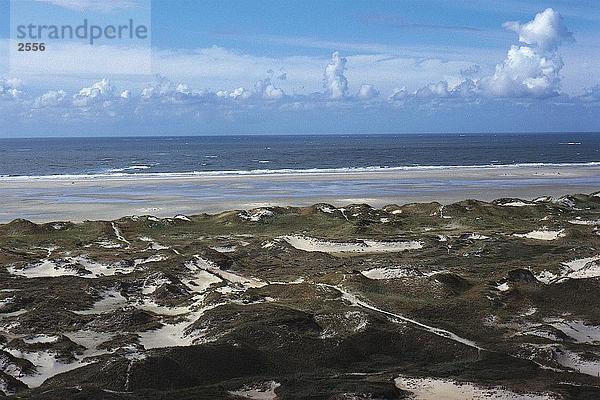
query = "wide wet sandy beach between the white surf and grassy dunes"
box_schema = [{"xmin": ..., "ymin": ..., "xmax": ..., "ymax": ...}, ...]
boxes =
[{"xmin": 0, "ymin": 163, "xmax": 600, "ymax": 222}]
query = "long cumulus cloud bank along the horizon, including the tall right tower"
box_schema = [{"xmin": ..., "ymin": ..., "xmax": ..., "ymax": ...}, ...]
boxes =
[{"xmin": 0, "ymin": 7, "xmax": 600, "ymax": 134}]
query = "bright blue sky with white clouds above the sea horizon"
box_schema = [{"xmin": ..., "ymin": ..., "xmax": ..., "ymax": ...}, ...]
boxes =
[{"xmin": 0, "ymin": 0, "xmax": 600, "ymax": 137}]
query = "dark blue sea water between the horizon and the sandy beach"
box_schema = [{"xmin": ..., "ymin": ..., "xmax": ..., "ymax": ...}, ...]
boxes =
[{"xmin": 0, "ymin": 133, "xmax": 600, "ymax": 176}]
